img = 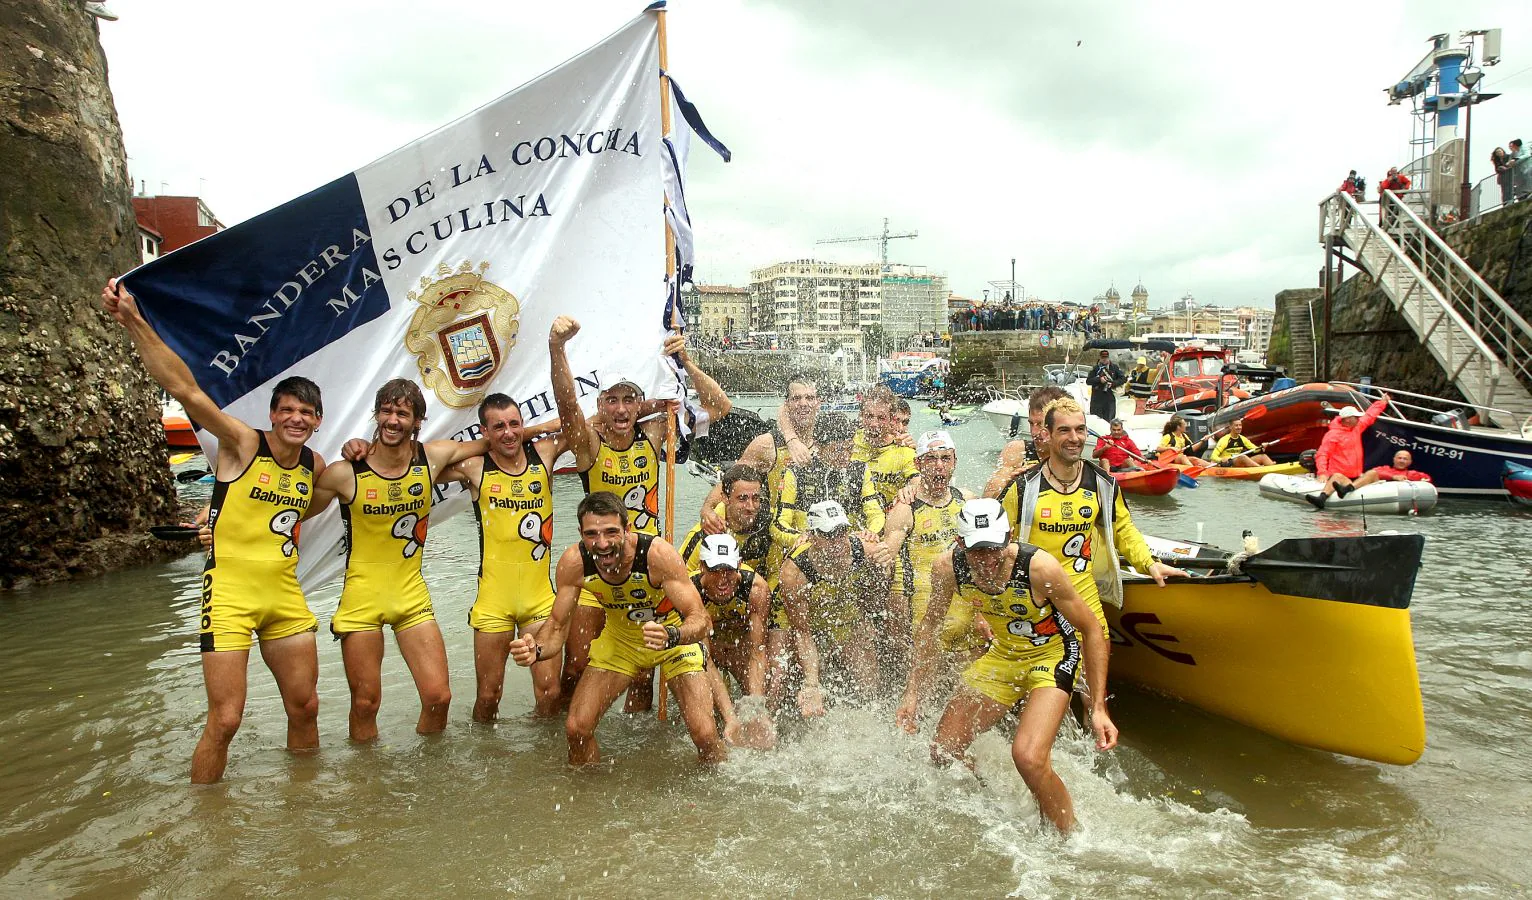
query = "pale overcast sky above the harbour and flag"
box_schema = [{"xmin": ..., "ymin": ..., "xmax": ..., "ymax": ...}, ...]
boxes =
[{"xmin": 101, "ymin": 0, "xmax": 1532, "ymax": 305}]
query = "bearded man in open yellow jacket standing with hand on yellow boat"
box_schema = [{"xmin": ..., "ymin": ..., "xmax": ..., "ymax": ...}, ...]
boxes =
[{"xmin": 1000, "ymin": 397, "xmax": 1186, "ymax": 633}]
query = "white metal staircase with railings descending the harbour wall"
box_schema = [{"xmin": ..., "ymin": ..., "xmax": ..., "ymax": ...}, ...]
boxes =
[{"xmin": 1319, "ymin": 190, "xmax": 1532, "ymax": 429}]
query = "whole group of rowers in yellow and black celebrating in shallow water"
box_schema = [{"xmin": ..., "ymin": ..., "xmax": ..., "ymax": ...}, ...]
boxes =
[{"xmin": 103, "ymin": 279, "xmax": 1184, "ymax": 833}]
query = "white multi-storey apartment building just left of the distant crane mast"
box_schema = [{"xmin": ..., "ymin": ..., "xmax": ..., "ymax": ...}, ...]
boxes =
[{"xmin": 748, "ymin": 259, "xmax": 882, "ymax": 350}]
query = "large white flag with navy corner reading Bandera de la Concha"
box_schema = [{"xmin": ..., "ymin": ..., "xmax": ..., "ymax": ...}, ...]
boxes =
[{"xmin": 116, "ymin": 11, "xmax": 674, "ymax": 584}]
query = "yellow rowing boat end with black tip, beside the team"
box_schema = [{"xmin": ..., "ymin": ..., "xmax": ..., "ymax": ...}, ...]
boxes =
[{"xmin": 1106, "ymin": 535, "xmax": 1426, "ymax": 765}]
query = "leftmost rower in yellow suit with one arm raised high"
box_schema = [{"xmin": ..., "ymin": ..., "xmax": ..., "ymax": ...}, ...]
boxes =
[{"xmin": 101, "ymin": 279, "xmax": 325, "ymax": 783}]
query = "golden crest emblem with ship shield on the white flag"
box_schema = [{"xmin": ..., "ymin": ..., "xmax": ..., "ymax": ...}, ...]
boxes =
[{"xmin": 404, "ymin": 262, "xmax": 521, "ymax": 409}]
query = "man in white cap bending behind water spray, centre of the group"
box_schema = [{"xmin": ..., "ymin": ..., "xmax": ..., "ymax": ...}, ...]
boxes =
[{"xmin": 778, "ymin": 500, "xmax": 892, "ymax": 718}]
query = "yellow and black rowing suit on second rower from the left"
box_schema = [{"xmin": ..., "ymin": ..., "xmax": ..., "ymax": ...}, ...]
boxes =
[{"xmin": 329, "ymin": 442, "xmax": 437, "ymax": 638}]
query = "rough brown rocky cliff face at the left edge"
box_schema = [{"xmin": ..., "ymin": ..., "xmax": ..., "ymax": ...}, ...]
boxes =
[{"xmin": 0, "ymin": 0, "xmax": 175, "ymax": 587}]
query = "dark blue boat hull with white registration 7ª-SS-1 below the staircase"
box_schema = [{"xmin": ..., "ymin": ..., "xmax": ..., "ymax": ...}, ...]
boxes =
[{"xmin": 1362, "ymin": 417, "xmax": 1532, "ymax": 497}]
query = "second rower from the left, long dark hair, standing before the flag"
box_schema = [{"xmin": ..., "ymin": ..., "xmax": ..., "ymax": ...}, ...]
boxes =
[{"xmin": 317, "ymin": 379, "xmax": 484, "ymax": 741}]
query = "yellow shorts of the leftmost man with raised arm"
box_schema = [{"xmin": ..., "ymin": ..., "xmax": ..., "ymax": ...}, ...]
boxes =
[{"xmin": 199, "ymin": 558, "xmax": 319, "ymax": 653}]
